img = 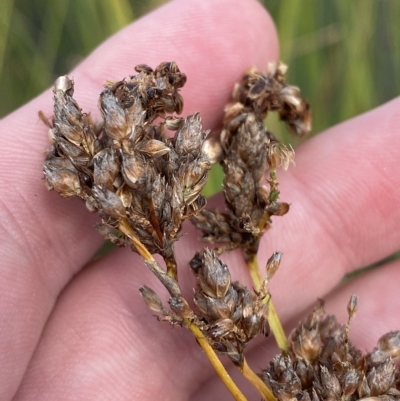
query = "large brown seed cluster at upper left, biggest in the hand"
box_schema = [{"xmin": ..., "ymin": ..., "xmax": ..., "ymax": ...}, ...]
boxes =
[{"xmin": 43, "ymin": 62, "xmax": 210, "ymax": 268}]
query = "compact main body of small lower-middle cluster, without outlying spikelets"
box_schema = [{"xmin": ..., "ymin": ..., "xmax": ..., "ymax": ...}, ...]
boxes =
[{"xmin": 190, "ymin": 248, "xmax": 269, "ymax": 364}]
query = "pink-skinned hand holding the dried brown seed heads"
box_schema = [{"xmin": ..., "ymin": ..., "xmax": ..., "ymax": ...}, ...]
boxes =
[{"xmin": 0, "ymin": 0, "xmax": 400, "ymax": 401}]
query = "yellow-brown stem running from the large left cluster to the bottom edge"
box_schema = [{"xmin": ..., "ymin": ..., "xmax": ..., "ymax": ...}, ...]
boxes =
[{"xmin": 118, "ymin": 219, "xmax": 247, "ymax": 401}]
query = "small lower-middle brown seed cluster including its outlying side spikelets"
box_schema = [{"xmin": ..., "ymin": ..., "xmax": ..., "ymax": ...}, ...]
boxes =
[{"xmin": 140, "ymin": 248, "xmax": 281, "ymax": 365}]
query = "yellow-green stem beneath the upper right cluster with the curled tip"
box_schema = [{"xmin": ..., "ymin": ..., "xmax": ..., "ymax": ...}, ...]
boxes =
[{"xmin": 247, "ymin": 254, "xmax": 288, "ymax": 352}]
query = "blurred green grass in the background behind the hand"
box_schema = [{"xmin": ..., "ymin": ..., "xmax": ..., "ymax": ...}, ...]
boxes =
[{"xmin": 0, "ymin": 0, "xmax": 400, "ymax": 268}]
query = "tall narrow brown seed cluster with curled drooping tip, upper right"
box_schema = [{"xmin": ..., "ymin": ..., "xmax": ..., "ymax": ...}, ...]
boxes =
[{"xmin": 192, "ymin": 64, "xmax": 311, "ymax": 255}]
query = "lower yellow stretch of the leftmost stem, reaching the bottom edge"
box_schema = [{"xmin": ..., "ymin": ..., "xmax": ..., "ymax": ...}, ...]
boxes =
[{"xmin": 185, "ymin": 319, "xmax": 247, "ymax": 401}]
